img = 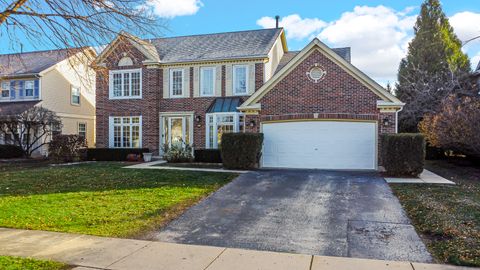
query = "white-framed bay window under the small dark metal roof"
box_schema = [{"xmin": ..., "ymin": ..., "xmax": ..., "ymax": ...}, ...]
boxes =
[{"xmin": 206, "ymin": 112, "xmax": 245, "ymax": 148}]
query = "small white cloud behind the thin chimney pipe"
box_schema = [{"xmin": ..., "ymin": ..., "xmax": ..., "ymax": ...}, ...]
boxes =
[{"xmin": 257, "ymin": 14, "xmax": 327, "ymax": 39}]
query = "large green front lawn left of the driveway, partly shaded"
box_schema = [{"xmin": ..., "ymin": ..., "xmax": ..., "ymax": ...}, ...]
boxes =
[{"xmin": 0, "ymin": 162, "xmax": 236, "ymax": 237}]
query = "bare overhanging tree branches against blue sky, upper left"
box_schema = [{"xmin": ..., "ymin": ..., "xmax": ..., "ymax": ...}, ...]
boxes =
[{"xmin": 0, "ymin": 0, "xmax": 166, "ymax": 51}]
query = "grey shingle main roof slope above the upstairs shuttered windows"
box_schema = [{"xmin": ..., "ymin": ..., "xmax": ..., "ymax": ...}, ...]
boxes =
[{"xmin": 151, "ymin": 29, "xmax": 282, "ymax": 63}]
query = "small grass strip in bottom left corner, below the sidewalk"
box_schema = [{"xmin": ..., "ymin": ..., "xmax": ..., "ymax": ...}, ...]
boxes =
[{"xmin": 0, "ymin": 256, "xmax": 70, "ymax": 270}]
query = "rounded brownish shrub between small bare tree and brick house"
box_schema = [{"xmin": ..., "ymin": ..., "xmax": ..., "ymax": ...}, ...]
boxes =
[{"xmin": 48, "ymin": 135, "xmax": 87, "ymax": 162}]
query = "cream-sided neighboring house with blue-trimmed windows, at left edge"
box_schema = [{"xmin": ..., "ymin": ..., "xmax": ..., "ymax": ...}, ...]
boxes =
[{"xmin": 0, "ymin": 48, "xmax": 96, "ymax": 155}]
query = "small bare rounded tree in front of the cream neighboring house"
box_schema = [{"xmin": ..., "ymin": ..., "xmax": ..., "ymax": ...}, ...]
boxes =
[{"xmin": 0, "ymin": 107, "xmax": 62, "ymax": 157}]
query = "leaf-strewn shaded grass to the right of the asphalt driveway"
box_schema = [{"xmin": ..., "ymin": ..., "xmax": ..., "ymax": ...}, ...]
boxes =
[{"xmin": 391, "ymin": 161, "xmax": 480, "ymax": 266}]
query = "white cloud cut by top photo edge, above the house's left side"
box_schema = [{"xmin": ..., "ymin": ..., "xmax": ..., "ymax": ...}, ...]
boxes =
[{"xmin": 144, "ymin": 0, "xmax": 203, "ymax": 18}]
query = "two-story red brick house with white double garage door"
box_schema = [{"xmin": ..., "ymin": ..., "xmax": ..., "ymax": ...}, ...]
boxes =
[{"xmin": 96, "ymin": 28, "xmax": 403, "ymax": 169}]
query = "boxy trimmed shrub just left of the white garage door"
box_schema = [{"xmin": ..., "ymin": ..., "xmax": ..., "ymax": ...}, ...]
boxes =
[{"xmin": 221, "ymin": 133, "xmax": 263, "ymax": 169}]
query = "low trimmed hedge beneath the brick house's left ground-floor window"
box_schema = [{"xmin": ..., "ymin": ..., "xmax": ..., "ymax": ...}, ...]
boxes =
[{"xmin": 87, "ymin": 148, "xmax": 150, "ymax": 161}]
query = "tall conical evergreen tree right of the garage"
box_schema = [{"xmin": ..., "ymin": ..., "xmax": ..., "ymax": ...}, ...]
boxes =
[{"xmin": 395, "ymin": 0, "xmax": 470, "ymax": 132}]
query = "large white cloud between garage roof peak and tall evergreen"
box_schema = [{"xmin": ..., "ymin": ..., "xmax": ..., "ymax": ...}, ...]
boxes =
[{"xmin": 319, "ymin": 6, "xmax": 416, "ymax": 81}]
